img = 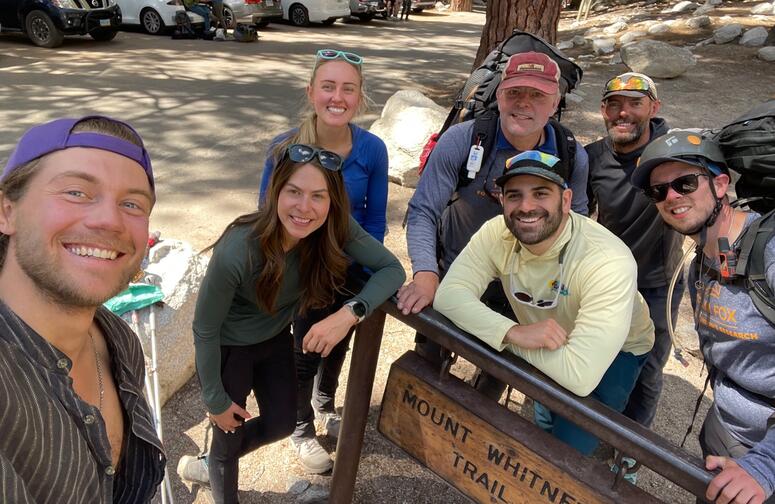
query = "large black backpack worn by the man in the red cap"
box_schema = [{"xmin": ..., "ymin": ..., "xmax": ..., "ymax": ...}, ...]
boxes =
[{"xmin": 419, "ymin": 30, "xmax": 583, "ymax": 184}]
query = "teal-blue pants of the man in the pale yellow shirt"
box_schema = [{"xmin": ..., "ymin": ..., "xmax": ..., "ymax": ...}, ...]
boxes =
[{"xmin": 533, "ymin": 352, "xmax": 648, "ymax": 455}]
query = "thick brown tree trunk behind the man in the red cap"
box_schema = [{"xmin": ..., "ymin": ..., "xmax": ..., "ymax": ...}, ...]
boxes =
[{"xmin": 473, "ymin": 0, "xmax": 561, "ymax": 68}]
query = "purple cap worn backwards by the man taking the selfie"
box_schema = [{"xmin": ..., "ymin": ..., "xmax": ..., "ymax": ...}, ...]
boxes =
[{"xmin": 0, "ymin": 115, "xmax": 156, "ymax": 191}]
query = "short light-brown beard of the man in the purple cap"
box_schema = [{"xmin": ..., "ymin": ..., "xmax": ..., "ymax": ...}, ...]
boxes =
[{"xmin": 13, "ymin": 230, "xmax": 140, "ymax": 308}]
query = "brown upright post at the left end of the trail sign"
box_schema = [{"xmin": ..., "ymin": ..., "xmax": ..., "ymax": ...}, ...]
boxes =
[{"xmin": 329, "ymin": 310, "xmax": 390, "ymax": 504}]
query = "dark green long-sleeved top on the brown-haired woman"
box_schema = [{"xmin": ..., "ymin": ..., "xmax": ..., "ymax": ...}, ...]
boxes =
[{"xmin": 193, "ymin": 218, "xmax": 406, "ymax": 414}]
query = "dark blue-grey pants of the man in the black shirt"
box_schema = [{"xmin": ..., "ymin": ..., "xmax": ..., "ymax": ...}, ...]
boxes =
[{"xmin": 622, "ymin": 276, "xmax": 686, "ymax": 428}]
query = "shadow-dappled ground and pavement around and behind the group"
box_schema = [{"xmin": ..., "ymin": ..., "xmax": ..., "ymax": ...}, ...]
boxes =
[{"xmin": 0, "ymin": 2, "xmax": 775, "ymax": 504}]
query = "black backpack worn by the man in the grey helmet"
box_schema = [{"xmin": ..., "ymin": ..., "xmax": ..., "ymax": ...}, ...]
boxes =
[{"xmin": 714, "ymin": 100, "xmax": 775, "ymax": 325}]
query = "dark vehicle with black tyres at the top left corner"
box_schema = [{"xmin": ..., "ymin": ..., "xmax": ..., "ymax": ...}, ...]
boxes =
[{"xmin": 0, "ymin": 0, "xmax": 121, "ymax": 47}]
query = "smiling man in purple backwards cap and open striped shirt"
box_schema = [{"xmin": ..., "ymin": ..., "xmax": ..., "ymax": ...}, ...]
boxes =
[{"xmin": 0, "ymin": 116, "xmax": 165, "ymax": 503}]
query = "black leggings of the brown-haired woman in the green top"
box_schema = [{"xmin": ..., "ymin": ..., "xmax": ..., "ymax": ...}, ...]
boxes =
[{"xmin": 207, "ymin": 327, "xmax": 296, "ymax": 504}]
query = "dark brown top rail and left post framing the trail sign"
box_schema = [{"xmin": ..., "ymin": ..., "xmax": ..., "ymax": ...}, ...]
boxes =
[{"xmin": 330, "ymin": 298, "xmax": 713, "ymax": 504}]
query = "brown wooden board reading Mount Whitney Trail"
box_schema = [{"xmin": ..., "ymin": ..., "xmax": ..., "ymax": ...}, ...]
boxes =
[{"xmin": 379, "ymin": 352, "xmax": 660, "ymax": 504}]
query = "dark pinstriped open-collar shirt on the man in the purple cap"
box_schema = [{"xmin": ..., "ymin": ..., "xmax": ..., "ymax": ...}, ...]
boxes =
[{"xmin": 0, "ymin": 302, "xmax": 166, "ymax": 504}]
